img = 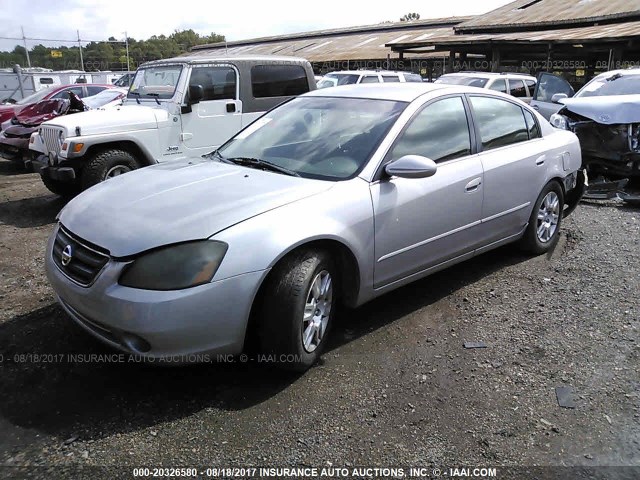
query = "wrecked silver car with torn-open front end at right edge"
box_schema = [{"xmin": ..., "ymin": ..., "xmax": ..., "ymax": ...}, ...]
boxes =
[{"xmin": 531, "ymin": 69, "xmax": 640, "ymax": 199}]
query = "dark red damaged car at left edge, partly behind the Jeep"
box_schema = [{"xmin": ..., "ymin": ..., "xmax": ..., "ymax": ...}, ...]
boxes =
[{"xmin": 0, "ymin": 88, "xmax": 127, "ymax": 167}]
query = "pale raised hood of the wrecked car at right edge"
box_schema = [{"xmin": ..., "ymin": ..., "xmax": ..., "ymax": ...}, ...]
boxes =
[{"xmin": 561, "ymin": 95, "xmax": 640, "ymax": 125}]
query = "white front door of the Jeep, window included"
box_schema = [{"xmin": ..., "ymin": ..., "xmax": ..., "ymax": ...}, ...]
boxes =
[{"xmin": 181, "ymin": 64, "xmax": 242, "ymax": 154}]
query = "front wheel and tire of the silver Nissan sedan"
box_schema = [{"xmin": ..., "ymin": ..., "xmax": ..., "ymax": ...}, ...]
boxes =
[{"xmin": 258, "ymin": 250, "xmax": 339, "ymax": 372}]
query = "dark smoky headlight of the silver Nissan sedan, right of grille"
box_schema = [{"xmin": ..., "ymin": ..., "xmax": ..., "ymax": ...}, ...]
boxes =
[{"xmin": 118, "ymin": 240, "xmax": 228, "ymax": 290}]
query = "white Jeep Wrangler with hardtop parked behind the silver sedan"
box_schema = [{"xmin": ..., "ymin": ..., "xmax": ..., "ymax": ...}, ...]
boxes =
[{"xmin": 29, "ymin": 56, "xmax": 316, "ymax": 196}]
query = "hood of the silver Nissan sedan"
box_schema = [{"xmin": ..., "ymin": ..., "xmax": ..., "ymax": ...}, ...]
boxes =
[{"xmin": 59, "ymin": 158, "xmax": 333, "ymax": 257}]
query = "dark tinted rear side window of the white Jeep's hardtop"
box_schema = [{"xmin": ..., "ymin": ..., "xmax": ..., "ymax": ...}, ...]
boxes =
[{"xmin": 251, "ymin": 65, "xmax": 309, "ymax": 98}]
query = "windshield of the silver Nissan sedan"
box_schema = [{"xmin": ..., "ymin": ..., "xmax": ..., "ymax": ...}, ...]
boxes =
[{"xmin": 214, "ymin": 97, "xmax": 406, "ymax": 180}]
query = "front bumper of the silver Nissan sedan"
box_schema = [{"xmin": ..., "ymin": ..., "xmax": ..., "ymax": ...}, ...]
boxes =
[{"xmin": 45, "ymin": 228, "xmax": 266, "ymax": 363}]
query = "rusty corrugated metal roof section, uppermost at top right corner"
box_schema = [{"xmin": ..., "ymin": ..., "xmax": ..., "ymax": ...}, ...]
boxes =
[{"xmin": 455, "ymin": 0, "xmax": 640, "ymax": 33}]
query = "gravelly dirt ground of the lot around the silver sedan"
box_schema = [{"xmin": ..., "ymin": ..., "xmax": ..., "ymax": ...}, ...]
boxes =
[{"xmin": 0, "ymin": 160, "xmax": 640, "ymax": 478}]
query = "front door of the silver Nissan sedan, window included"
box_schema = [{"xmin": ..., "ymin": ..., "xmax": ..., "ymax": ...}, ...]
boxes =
[{"xmin": 371, "ymin": 96, "xmax": 484, "ymax": 288}]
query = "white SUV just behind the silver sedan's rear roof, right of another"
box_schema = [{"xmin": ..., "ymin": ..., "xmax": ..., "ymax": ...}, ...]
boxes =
[{"xmin": 434, "ymin": 72, "xmax": 537, "ymax": 103}]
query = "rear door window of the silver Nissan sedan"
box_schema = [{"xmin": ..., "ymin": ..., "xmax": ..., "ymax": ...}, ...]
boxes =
[{"xmin": 471, "ymin": 97, "xmax": 529, "ymax": 150}]
